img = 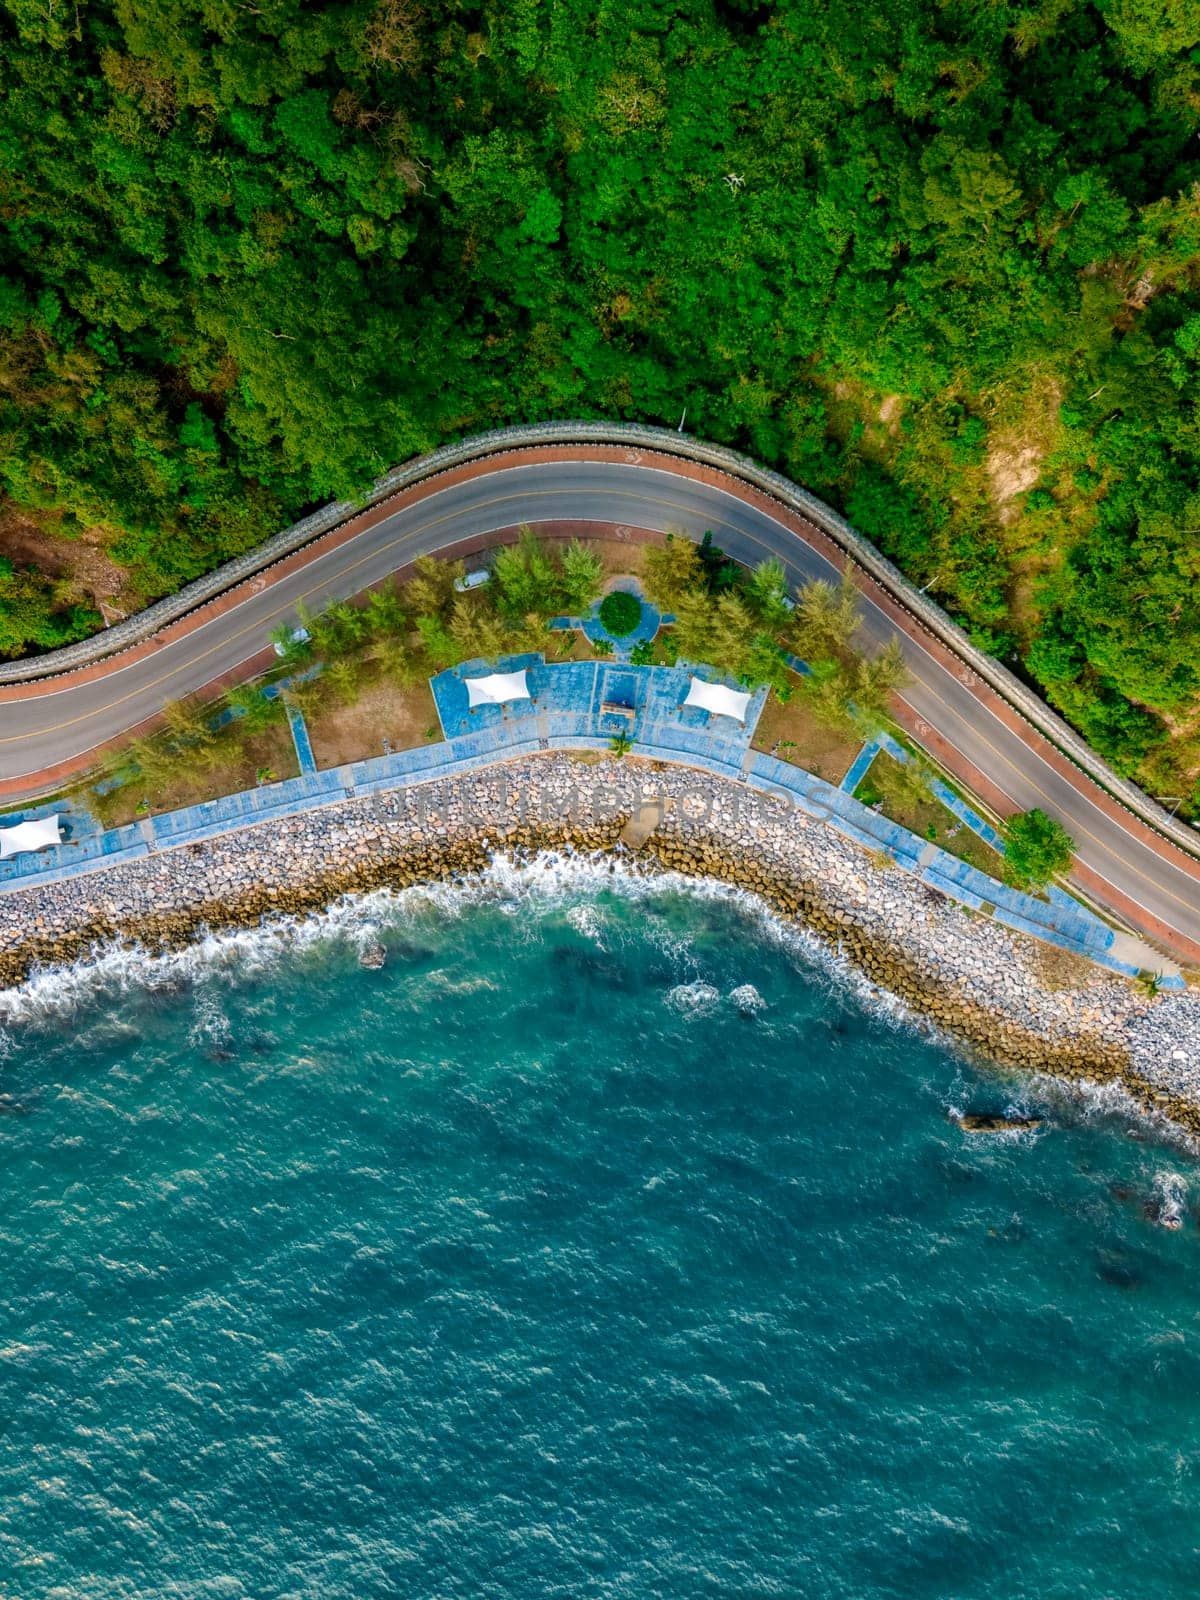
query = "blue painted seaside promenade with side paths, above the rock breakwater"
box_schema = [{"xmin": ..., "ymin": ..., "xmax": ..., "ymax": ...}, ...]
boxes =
[{"xmin": 0, "ymin": 654, "xmax": 1182, "ymax": 987}]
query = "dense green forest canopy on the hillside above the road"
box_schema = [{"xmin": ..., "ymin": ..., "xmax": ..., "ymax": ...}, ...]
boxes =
[{"xmin": 0, "ymin": 0, "xmax": 1200, "ymax": 813}]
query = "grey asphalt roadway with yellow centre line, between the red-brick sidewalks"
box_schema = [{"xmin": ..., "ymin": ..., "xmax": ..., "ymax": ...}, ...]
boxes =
[{"xmin": 0, "ymin": 456, "xmax": 1200, "ymax": 950}]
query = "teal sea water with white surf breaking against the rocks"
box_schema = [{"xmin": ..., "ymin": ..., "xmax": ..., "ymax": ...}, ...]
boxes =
[{"xmin": 0, "ymin": 866, "xmax": 1200, "ymax": 1600}]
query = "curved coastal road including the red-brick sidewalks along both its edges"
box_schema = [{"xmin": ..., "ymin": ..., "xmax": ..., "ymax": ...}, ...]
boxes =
[{"xmin": 0, "ymin": 445, "xmax": 1200, "ymax": 963}]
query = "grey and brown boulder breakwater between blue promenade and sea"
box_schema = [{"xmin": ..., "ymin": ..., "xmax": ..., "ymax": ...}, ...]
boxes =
[{"xmin": 0, "ymin": 754, "xmax": 1200, "ymax": 1134}]
